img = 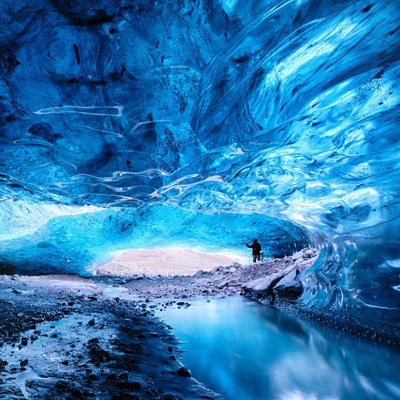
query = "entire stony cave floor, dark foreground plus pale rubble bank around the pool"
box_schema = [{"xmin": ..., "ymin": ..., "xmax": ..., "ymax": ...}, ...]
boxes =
[{"xmin": 0, "ymin": 249, "xmax": 396, "ymax": 400}]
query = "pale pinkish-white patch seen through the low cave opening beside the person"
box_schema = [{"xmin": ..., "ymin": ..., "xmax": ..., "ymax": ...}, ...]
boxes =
[{"xmin": 96, "ymin": 247, "xmax": 248, "ymax": 276}]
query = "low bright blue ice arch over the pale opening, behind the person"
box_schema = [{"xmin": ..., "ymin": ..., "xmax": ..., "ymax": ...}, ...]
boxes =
[{"xmin": 0, "ymin": 205, "xmax": 307, "ymax": 275}]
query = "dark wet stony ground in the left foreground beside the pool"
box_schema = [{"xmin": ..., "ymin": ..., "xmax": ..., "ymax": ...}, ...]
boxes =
[{"xmin": 0, "ymin": 277, "xmax": 218, "ymax": 400}]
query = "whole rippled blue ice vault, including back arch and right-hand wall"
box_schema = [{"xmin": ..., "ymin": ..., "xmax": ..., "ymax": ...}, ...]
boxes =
[{"xmin": 0, "ymin": 0, "xmax": 400, "ymax": 328}]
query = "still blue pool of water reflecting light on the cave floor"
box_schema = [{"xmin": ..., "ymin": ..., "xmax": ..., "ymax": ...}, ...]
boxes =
[{"xmin": 160, "ymin": 297, "xmax": 400, "ymax": 400}]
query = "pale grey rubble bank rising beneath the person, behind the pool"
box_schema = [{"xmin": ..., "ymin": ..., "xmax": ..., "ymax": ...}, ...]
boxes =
[{"xmin": 95, "ymin": 249, "xmax": 317, "ymax": 306}]
